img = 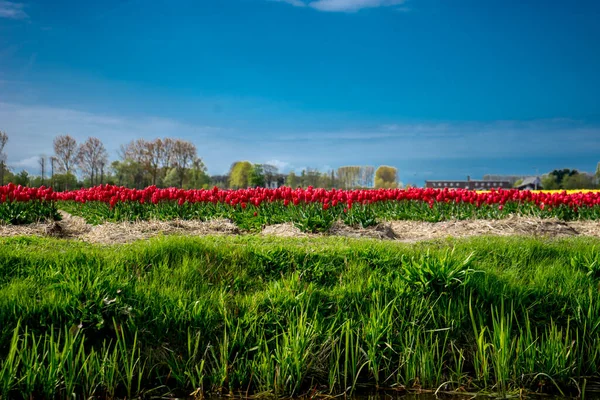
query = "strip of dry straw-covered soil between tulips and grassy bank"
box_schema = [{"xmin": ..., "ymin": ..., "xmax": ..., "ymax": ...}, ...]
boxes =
[{"xmin": 0, "ymin": 211, "xmax": 600, "ymax": 244}]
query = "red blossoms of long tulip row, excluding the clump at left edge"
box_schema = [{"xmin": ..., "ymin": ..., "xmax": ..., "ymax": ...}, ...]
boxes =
[{"xmin": 51, "ymin": 185, "xmax": 600, "ymax": 209}]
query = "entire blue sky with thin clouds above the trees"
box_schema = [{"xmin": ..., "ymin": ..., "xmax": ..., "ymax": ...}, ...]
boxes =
[{"xmin": 0, "ymin": 0, "xmax": 600, "ymax": 184}]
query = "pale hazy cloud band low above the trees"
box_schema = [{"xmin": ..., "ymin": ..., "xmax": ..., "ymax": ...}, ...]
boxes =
[{"xmin": 0, "ymin": 102, "xmax": 600, "ymax": 180}]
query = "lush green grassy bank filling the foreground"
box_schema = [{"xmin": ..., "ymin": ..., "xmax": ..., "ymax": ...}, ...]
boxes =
[{"xmin": 0, "ymin": 236, "xmax": 600, "ymax": 398}]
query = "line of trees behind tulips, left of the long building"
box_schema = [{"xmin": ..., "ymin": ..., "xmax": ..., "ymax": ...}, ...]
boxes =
[{"xmin": 0, "ymin": 131, "xmax": 399, "ymax": 190}]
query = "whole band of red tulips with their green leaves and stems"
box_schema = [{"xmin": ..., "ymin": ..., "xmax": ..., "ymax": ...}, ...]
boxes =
[{"xmin": 0, "ymin": 184, "xmax": 600, "ymax": 228}]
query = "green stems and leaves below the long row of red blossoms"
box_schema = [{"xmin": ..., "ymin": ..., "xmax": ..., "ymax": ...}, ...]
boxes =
[{"xmin": 57, "ymin": 200, "xmax": 600, "ymax": 233}]
